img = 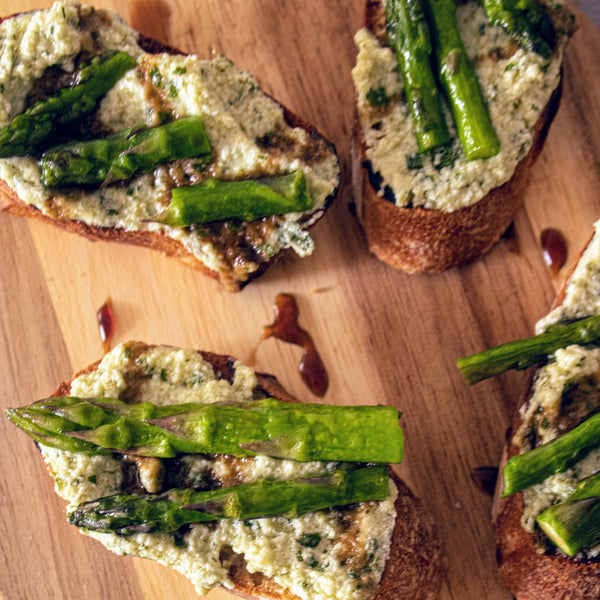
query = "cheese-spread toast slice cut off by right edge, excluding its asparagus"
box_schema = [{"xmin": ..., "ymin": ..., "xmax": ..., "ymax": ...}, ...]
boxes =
[{"xmin": 493, "ymin": 223, "xmax": 600, "ymax": 600}]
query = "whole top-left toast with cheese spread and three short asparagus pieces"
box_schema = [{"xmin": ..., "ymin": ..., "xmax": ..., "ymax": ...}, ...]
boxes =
[{"xmin": 0, "ymin": 1, "xmax": 339, "ymax": 291}]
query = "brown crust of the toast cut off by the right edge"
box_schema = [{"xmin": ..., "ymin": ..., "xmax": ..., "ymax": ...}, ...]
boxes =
[{"xmin": 492, "ymin": 236, "xmax": 600, "ymax": 600}]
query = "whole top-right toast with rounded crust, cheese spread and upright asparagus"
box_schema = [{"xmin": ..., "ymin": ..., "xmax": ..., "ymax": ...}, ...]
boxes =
[{"xmin": 352, "ymin": 0, "xmax": 574, "ymax": 273}]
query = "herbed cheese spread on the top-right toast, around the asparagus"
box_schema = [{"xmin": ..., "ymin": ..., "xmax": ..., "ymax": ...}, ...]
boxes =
[{"xmin": 352, "ymin": 1, "xmax": 566, "ymax": 212}]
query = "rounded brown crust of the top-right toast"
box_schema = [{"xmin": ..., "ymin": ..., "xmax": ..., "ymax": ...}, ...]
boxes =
[{"xmin": 352, "ymin": 0, "xmax": 562, "ymax": 273}]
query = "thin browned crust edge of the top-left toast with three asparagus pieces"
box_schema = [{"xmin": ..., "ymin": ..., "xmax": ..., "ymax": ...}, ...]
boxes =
[{"xmin": 0, "ymin": 13, "xmax": 339, "ymax": 292}]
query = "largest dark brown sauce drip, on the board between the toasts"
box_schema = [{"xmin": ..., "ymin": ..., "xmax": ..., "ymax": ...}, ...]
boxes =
[{"xmin": 262, "ymin": 294, "xmax": 329, "ymax": 397}]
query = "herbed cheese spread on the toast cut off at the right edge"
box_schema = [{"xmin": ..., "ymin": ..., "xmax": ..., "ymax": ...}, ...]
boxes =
[{"xmin": 518, "ymin": 221, "xmax": 600, "ymax": 558}]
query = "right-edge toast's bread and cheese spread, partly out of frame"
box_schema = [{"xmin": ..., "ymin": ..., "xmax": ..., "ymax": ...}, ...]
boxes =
[{"xmin": 494, "ymin": 223, "xmax": 600, "ymax": 600}]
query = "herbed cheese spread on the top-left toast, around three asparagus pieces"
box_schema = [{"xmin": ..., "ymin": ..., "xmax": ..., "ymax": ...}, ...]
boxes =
[{"xmin": 0, "ymin": 1, "xmax": 339, "ymax": 286}]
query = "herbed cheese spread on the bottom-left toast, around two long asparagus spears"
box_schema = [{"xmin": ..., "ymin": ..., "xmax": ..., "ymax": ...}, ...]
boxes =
[{"xmin": 42, "ymin": 343, "xmax": 396, "ymax": 600}]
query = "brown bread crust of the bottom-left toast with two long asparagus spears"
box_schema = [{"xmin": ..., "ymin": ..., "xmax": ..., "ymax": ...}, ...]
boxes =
[{"xmin": 52, "ymin": 342, "xmax": 447, "ymax": 600}]
